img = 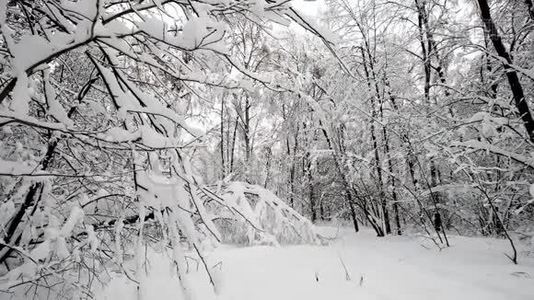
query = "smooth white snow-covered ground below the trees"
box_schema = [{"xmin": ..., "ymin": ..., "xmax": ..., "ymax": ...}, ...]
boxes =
[{"xmin": 97, "ymin": 228, "xmax": 534, "ymax": 300}]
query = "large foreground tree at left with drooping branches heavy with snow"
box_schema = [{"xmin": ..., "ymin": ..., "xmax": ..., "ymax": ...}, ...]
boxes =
[{"xmin": 0, "ymin": 0, "xmax": 330, "ymax": 298}]
